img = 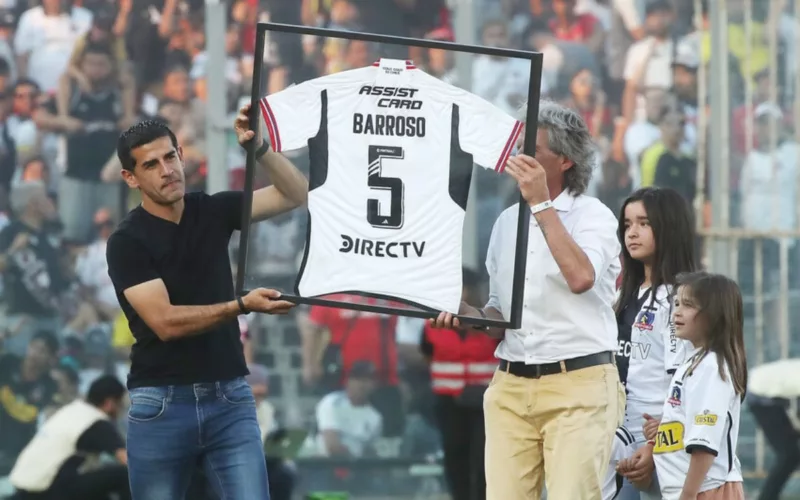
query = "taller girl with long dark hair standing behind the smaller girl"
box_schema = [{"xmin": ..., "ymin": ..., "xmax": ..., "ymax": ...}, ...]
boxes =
[{"xmin": 610, "ymin": 188, "xmax": 696, "ymax": 500}]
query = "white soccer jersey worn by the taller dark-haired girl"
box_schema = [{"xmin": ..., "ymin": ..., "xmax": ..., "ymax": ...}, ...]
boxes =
[{"xmin": 618, "ymin": 285, "xmax": 691, "ymax": 444}]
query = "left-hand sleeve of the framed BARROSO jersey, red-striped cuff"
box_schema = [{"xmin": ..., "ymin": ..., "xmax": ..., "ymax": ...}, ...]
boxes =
[{"xmin": 259, "ymin": 79, "xmax": 323, "ymax": 153}]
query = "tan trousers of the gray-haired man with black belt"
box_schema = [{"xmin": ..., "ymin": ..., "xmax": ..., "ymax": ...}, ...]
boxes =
[{"xmin": 483, "ymin": 364, "xmax": 625, "ymax": 500}]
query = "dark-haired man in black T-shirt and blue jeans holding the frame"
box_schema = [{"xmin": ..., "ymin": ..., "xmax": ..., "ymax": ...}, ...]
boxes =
[{"xmin": 106, "ymin": 111, "xmax": 308, "ymax": 500}]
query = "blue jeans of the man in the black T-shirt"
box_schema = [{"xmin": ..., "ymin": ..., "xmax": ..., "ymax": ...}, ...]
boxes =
[{"xmin": 128, "ymin": 377, "xmax": 269, "ymax": 500}]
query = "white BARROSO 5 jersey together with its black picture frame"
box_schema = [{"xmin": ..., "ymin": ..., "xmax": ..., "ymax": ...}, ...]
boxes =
[{"xmin": 236, "ymin": 23, "xmax": 542, "ymax": 328}]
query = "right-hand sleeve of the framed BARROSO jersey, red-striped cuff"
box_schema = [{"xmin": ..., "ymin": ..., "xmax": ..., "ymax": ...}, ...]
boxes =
[{"xmin": 455, "ymin": 92, "xmax": 523, "ymax": 172}]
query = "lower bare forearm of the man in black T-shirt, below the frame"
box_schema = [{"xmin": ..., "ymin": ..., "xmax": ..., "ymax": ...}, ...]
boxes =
[{"xmin": 159, "ymin": 300, "xmax": 241, "ymax": 341}]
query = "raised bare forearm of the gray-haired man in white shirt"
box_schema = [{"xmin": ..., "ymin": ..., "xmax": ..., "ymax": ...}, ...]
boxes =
[{"xmin": 534, "ymin": 208, "xmax": 595, "ymax": 293}]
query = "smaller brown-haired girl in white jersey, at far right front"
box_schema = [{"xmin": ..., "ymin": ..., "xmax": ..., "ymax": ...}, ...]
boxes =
[{"xmin": 647, "ymin": 272, "xmax": 747, "ymax": 500}]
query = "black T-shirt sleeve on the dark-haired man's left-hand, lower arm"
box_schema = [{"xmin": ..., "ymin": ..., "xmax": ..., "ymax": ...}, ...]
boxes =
[{"xmin": 106, "ymin": 233, "xmax": 161, "ymax": 293}]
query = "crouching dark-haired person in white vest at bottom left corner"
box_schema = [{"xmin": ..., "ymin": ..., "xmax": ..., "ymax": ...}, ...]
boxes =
[{"xmin": 10, "ymin": 376, "xmax": 131, "ymax": 500}]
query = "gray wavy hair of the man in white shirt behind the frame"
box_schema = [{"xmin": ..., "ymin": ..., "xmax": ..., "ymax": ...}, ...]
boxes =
[{"xmin": 520, "ymin": 100, "xmax": 597, "ymax": 196}]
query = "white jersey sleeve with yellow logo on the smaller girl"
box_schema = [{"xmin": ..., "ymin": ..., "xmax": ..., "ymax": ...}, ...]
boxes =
[{"xmin": 684, "ymin": 362, "xmax": 737, "ymax": 456}]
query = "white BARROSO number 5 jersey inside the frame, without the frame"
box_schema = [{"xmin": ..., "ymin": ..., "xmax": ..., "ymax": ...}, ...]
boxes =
[{"xmin": 261, "ymin": 59, "xmax": 522, "ymax": 313}]
